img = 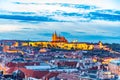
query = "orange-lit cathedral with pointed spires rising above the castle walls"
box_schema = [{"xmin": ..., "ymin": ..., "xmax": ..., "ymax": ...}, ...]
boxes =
[{"xmin": 52, "ymin": 32, "xmax": 68, "ymax": 43}]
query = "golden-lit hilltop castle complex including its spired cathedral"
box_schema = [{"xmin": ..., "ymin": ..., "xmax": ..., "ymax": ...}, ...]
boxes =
[{"xmin": 22, "ymin": 32, "xmax": 94, "ymax": 50}]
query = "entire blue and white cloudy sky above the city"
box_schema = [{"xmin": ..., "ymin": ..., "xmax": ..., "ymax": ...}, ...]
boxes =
[{"xmin": 0, "ymin": 0, "xmax": 120, "ymax": 43}]
